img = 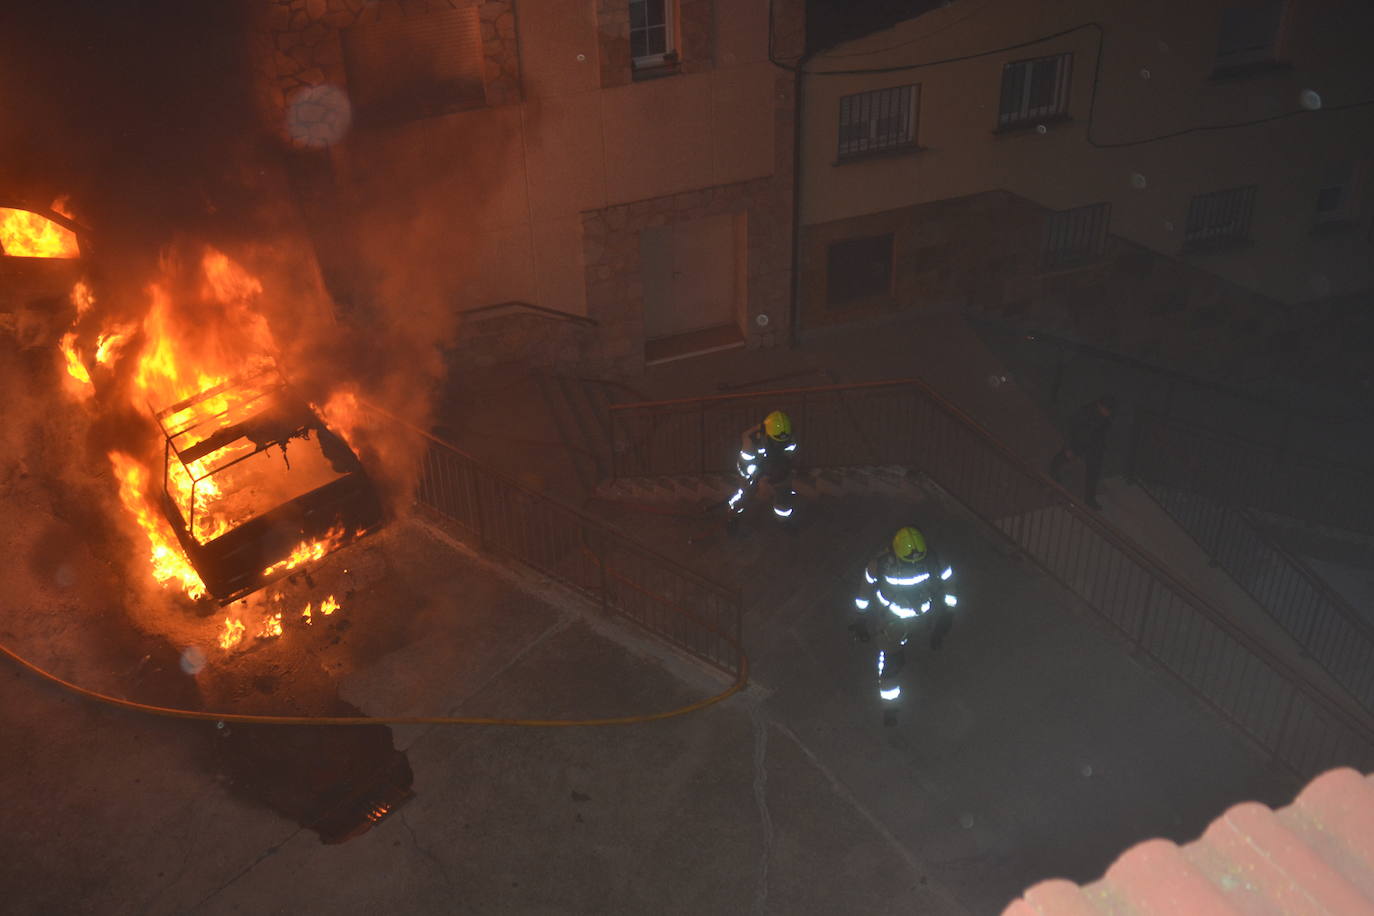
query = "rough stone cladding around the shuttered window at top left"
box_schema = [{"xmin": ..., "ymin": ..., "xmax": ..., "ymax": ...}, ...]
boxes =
[{"xmin": 253, "ymin": 0, "xmax": 521, "ymax": 141}]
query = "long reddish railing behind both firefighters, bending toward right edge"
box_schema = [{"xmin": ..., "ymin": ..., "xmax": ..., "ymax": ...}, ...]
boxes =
[{"xmin": 611, "ymin": 379, "xmax": 1374, "ymax": 776}]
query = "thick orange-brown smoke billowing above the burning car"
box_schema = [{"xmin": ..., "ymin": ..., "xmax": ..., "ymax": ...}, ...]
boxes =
[{"xmin": 0, "ymin": 0, "xmax": 510, "ymax": 516}]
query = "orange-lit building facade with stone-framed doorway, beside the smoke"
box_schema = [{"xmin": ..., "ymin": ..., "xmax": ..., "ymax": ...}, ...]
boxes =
[{"xmin": 254, "ymin": 0, "xmax": 802, "ymax": 372}]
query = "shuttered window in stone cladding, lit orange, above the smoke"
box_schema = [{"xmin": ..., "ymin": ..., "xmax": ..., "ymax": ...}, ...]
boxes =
[{"xmin": 342, "ymin": 7, "xmax": 486, "ymax": 122}]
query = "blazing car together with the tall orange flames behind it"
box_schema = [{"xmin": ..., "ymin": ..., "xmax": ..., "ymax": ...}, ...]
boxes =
[{"xmin": 0, "ymin": 203, "xmax": 382, "ymax": 604}]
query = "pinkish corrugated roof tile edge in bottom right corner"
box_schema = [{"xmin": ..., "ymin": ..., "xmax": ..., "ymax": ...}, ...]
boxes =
[{"xmin": 1003, "ymin": 766, "xmax": 1374, "ymax": 916}]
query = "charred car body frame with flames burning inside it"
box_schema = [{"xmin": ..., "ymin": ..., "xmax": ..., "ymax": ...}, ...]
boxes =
[{"xmin": 154, "ymin": 365, "xmax": 382, "ymax": 604}]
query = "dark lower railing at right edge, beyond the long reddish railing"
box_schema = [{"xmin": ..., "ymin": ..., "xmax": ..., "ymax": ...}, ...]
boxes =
[{"xmin": 1140, "ymin": 479, "xmax": 1374, "ymax": 713}]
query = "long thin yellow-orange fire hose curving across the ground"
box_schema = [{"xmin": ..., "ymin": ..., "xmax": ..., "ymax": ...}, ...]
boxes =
[{"xmin": 0, "ymin": 643, "xmax": 749, "ymax": 728}]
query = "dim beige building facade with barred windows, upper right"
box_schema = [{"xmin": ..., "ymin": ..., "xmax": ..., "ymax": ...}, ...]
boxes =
[{"xmin": 798, "ymin": 0, "xmax": 1374, "ymax": 376}]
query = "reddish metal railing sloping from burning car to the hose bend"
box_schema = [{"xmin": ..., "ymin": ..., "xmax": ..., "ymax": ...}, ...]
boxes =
[{"xmin": 362, "ymin": 408, "xmax": 743, "ymax": 676}]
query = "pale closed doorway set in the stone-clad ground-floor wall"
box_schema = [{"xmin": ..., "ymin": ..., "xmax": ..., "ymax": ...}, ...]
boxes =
[{"xmin": 639, "ymin": 213, "xmax": 747, "ymax": 363}]
